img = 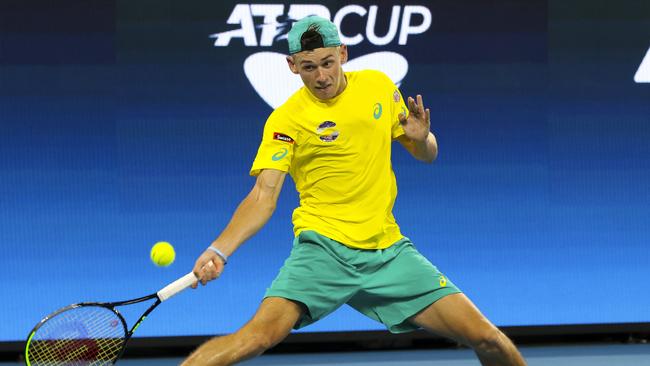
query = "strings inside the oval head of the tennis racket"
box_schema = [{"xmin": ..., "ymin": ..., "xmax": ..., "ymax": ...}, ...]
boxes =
[{"xmin": 27, "ymin": 306, "xmax": 126, "ymax": 366}]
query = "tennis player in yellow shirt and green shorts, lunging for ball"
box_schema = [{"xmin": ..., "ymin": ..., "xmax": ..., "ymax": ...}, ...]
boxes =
[{"xmin": 183, "ymin": 16, "xmax": 525, "ymax": 366}]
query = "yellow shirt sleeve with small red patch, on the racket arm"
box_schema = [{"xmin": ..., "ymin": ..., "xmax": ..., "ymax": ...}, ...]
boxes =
[{"xmin": 250, "ymin": 109, "xmax": 296, "ymax": 177}]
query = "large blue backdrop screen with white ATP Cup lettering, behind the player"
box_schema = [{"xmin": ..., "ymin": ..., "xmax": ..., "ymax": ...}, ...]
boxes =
[{"xmin": 0, "ymin": 0, "xmax": 650, "ymax": 341}]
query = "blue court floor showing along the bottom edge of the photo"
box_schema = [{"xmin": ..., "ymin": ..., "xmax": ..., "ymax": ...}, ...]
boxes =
[{"xmin": 5, "ymin": 344, "xmax": 650, "ymax": 366}]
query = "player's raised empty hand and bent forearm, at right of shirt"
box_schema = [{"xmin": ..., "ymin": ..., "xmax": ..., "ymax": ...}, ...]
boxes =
[{"xmin": 397, "ymin": 94, "xmax": 438, "ymax": 163}]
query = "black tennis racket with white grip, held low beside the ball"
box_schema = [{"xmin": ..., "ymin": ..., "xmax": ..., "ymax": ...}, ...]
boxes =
[{"xmin": 25, "ymin": 272, "xmax": 197, "ymax": 366}]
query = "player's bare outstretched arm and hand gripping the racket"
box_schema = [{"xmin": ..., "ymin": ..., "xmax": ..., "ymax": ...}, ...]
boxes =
[{"xmin": 192, "ymin": 169, "xmax": 287, "ymax": 288}]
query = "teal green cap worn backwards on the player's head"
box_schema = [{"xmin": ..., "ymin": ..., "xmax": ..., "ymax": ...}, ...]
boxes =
[{"xmin": 287, "ymin": 15, "xmax": 341, "ymax": 55}]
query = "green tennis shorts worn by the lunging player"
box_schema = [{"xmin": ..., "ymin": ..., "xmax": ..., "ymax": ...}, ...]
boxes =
[{"xmin": 265, "ymin": 231, "xmax": 460, "ymax": 333}]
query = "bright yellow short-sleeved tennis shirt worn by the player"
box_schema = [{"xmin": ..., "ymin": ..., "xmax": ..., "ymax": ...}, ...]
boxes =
[{"xmin": 250, "ymin": 70, "xmax": 407, "ymax": 249}]
